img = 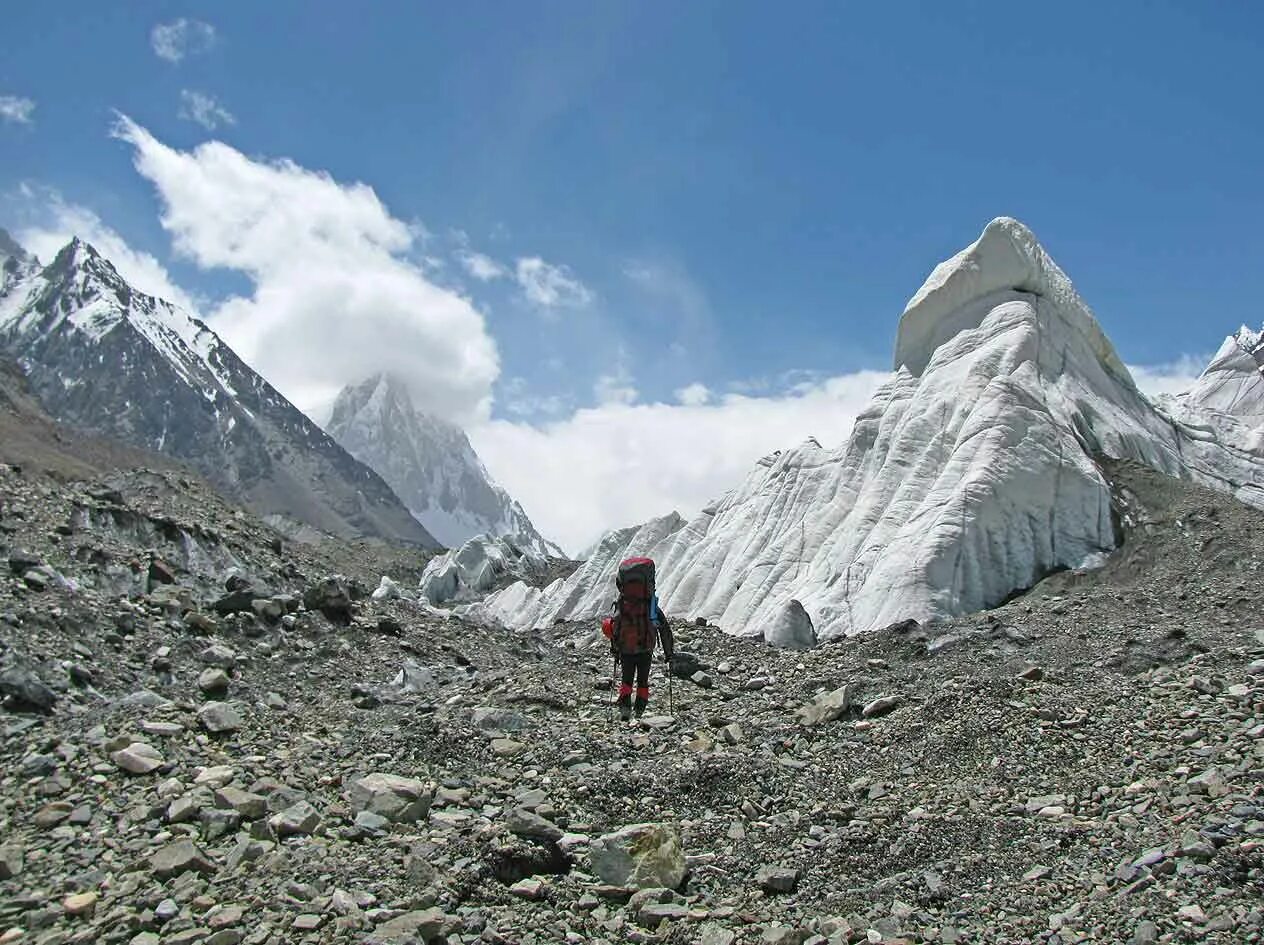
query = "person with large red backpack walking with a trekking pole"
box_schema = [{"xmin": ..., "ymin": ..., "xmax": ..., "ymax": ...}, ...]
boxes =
[{"xmin": 602, "ymin": 558, "xmax": 675, "ymax": 721}]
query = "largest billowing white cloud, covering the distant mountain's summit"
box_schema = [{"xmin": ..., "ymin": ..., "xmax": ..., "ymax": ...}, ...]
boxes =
[{"xmin": 115, "ymin": 117, "xmax": 499, "ymax": 423}]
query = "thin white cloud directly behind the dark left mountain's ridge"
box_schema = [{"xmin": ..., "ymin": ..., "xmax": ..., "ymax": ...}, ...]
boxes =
[{"xmin": 15, "ymin": 187, "xmax": 198, "ymax": 315}]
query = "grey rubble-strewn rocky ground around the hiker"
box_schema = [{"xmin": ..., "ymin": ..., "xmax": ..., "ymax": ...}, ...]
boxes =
[{"xmin": 0, "ymin": 452, "xmax": 1264, "ymax": 945}]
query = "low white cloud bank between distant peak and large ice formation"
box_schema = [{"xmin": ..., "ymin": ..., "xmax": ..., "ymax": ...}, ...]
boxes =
[{"xmin": 470, "ymin": 371, "xmax": 890, "ymax": 552}]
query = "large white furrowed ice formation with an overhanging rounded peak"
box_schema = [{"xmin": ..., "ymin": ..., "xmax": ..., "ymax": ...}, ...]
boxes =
[{"xmin": 478, "ymin": 217, "xmax": 1264, "ymax": 639}]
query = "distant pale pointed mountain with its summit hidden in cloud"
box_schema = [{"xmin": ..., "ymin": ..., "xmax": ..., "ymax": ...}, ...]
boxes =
[{"xmin": 326, "ymin": 374, "xmax": 562, "ymax": 557}]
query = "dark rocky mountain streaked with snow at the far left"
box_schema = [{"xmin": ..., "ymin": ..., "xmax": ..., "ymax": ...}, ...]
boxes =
[{"xmin": 0, "ymin": 231, "xmax": 437, "ymax": 547}]
